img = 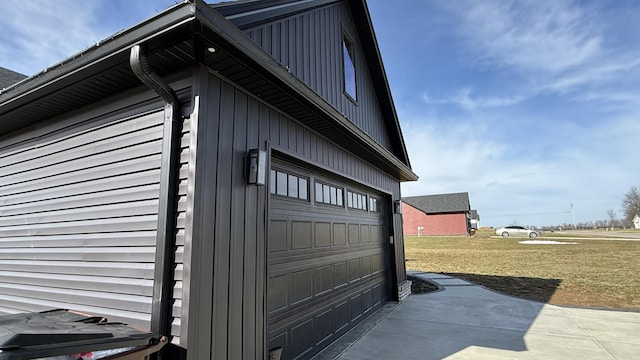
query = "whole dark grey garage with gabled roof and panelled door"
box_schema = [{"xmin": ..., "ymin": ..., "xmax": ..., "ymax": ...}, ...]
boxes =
[{"xmin": 0, "ymin": 0, "xmax": 417, "ymax": 360}]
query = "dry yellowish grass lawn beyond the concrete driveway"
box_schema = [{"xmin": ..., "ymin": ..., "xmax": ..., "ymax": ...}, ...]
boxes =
[{"xmin": 405, "ymin": 232, "xmax": 640, "ymax": 309}]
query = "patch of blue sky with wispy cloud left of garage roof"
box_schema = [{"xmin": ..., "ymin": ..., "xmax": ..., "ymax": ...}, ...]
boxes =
[{"xmin": 0, "ymin": 0, "xmax": 178, "ymax": 75}]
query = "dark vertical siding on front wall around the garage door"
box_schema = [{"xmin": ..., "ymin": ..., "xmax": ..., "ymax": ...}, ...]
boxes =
[{"xmin": 181, "ymin": 68, "xmax": 404, "ymax": 359}]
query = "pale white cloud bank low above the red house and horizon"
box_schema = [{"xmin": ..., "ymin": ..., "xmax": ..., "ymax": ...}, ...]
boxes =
[{"xmin": 402, "ymin": 114, "xmax": 640, "ymax": 226}]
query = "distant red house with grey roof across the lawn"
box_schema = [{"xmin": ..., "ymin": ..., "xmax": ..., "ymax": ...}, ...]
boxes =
[{"xmin": 402, "ymin": 192, "xmax": 470, "ymax": 235}]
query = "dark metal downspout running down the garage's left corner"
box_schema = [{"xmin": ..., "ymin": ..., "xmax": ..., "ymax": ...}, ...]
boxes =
[{"xmin": 129, "ymin": 45, "xmax": 182, "ymax": 346}]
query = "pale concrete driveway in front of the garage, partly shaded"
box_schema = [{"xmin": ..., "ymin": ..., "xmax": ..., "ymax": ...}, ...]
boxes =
[{"xmin": 318, "ymin": 273, "xmax": 640, "ymax": 360}]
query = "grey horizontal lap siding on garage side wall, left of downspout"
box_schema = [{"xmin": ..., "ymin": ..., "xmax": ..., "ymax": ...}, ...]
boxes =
[{"xmin": 0, "ymin": 107, "xmax": 163, "ymax": 328}]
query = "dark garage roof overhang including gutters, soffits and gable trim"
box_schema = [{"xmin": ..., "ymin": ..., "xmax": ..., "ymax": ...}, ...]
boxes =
[{"xmin": 0, "ymin": 0, "xmax": 417, "ymax": 181}]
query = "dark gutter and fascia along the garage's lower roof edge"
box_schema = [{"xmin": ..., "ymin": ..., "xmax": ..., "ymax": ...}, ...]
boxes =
[{"xmin": 0, "ymin": 0, "xmax": 418, "ymax": 181}]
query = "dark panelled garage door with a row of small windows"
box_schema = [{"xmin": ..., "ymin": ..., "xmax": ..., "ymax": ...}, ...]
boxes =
[{"xmin": 267, "ymin": 160, "xmax": 391, "ymax": 359}]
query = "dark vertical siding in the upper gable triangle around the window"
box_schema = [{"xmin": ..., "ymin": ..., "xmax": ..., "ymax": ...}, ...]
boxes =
[{"xmin": 244, "ymin": 2, "xmax": 393, "ymax": 152}]
